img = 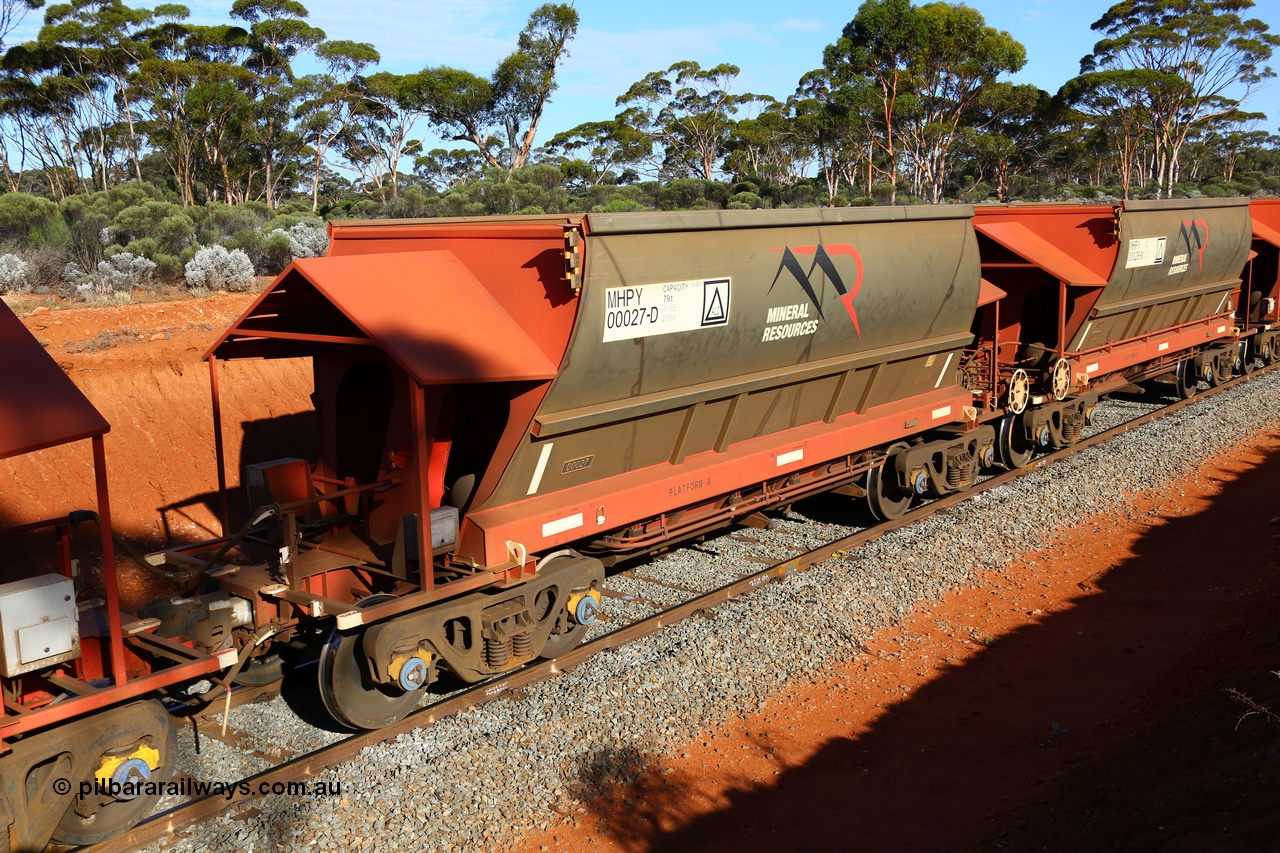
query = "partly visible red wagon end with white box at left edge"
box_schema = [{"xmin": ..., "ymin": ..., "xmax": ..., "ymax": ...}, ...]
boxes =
[{"xmin": 0, "ymin": 304, "xmax": 220, "ymax": 850}]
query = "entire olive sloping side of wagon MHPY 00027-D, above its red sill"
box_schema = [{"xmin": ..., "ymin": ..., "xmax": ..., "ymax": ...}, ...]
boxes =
[{"xmin": 495, "ymin": 206, "xmax": 980, "ymax": 501}]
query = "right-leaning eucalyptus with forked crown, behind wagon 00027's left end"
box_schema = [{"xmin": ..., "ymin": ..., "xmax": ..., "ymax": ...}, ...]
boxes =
[{"xmin": 421, "ymin": 3, "xmax": 579, "ymax": 175}]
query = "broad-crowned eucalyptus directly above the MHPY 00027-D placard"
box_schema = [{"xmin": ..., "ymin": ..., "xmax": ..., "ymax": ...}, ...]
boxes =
[{"xmin": 617, "ymin": 60, "xmax": 755, "ymax": 181}]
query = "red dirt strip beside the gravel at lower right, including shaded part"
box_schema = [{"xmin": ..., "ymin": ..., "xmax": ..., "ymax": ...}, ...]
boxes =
[{"xmin": 517, "ymin": 434, "xmax": 1280, "ymax": 853}]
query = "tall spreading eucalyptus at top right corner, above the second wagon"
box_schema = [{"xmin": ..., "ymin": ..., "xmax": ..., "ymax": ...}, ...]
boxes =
[{"xmin": 1078, "ymin": 0, "xmax": 1280, "ymax": 195}]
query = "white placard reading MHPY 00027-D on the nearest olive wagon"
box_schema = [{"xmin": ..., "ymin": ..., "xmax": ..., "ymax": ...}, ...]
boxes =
[{"xmin": 604, "ymin": 278, "xmax": 731, "ymax": 343}]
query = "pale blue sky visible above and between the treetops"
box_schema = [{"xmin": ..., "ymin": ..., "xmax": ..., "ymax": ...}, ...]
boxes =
[{"xmin": 10, "ymin": 0, "xmax": 1280, "ymax": 153}]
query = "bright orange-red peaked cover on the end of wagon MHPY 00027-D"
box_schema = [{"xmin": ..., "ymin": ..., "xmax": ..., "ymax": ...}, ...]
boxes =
[{"xmin": 206, "ymin": 251, "xmax": 556, "ymax": 386}]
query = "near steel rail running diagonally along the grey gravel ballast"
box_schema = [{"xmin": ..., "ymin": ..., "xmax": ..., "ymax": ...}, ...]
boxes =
[{"xmin": 91, "ymin": 365, "xmax": 1280, "ymax": 853}]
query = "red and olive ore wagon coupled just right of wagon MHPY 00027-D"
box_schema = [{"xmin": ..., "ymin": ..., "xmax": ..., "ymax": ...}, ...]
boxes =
[{"xmin": 965, "ymin": 199, "xmax": 1249, "ymax": 465}]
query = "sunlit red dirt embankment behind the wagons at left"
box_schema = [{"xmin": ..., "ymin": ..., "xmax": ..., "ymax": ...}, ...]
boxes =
[{"xmin": 0, "ymin": 295, "xmax": 314, "ymax": 606}]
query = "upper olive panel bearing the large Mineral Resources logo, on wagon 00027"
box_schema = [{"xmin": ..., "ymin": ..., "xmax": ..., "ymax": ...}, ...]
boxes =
[{"xmin": 552, "ymin": 211, "xmax": 979, "ymax": 414}]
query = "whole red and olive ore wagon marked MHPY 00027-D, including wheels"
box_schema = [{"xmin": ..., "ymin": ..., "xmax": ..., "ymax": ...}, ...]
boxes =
[{"xmin": 194, "ymin": 206, "xmax": 995, "ymax": 726}]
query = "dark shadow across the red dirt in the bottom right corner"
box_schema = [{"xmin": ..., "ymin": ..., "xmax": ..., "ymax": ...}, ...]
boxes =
[{"xmin": 579, "ymin": 432, "xmax": 1280, "ymax": 852}]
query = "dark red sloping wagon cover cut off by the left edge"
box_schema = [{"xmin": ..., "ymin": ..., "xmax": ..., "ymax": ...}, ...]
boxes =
[{"xmin": 0, "ymin": 302, "xmax": 110, "ymax": 459}]
